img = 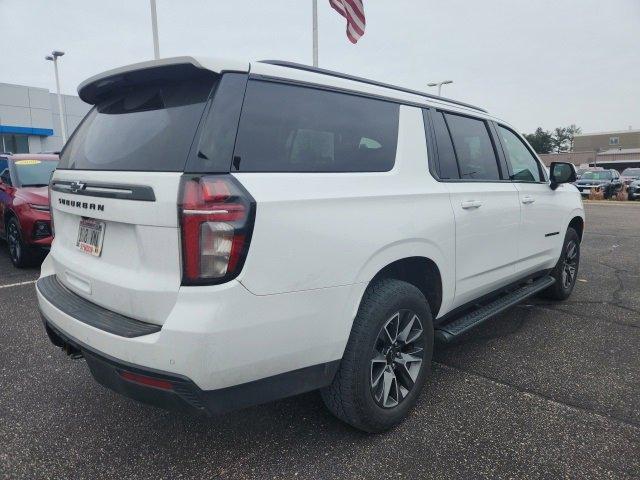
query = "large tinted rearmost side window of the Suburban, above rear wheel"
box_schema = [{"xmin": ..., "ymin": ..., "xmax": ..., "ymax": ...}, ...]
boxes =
[{"xmin": 233, "ymin": 81, "xmax": 399, "ymax": 172}]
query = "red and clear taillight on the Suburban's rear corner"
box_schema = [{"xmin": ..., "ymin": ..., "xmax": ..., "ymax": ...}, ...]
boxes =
[{"xmin": 179, "ymin": 175, "xmax": 255, "ymax": 285}]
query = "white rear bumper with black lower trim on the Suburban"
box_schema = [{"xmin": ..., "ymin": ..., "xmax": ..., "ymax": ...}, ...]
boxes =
[{"xmin": 36, "ymin": 257, "xmax": 366, "ymax": 413}]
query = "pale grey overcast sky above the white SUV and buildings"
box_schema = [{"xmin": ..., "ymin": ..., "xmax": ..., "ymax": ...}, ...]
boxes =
[{"xmin": 0, "ymin": 0, "xmax": 640, "ymax": 132}]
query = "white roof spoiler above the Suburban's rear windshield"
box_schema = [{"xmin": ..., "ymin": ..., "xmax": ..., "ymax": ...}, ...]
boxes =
[{"xmin": 78, "ymin": 57, "xmax": 249, "ymax": 105}]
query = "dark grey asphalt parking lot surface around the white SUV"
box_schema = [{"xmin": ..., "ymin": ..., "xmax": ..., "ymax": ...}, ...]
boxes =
[{"xmin": 0, "ymin": 202, "xmax": 640, "ymax": 479}]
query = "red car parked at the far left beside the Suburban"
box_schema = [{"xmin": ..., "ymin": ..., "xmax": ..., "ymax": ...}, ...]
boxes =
[{"xmin": 0, "ymin": 154, "xmax": 58, "ymax": 268}]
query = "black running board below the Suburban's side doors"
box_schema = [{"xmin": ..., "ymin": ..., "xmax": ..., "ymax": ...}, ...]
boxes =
[{"xmin": 434, "ymin": 276, "xmax": 556, "ymax": 343}]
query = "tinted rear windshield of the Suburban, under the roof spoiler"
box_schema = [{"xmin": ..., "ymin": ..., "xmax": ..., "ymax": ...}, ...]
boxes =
[{"xmin": 59, "ymin": 72, "xmax": 217, "ymax": 172}]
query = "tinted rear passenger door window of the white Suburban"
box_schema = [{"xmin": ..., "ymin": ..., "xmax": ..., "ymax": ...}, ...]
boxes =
[{"xmin": 445, "ymin": 113, "xmax": 500, "ymax": 180}]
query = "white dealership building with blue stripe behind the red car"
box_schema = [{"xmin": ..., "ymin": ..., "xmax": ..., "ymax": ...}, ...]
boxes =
[{"xmin": 0, "ymin": 83, "xmax": 91, "ymax": 153}]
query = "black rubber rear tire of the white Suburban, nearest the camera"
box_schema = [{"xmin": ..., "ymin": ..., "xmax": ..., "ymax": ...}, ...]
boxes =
[{"xmin": 321, "ymin": 279, "xmax": 433, "ymax": 433}]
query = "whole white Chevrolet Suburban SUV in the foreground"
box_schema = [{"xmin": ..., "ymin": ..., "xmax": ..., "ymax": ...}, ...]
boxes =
[{"xmin": 37, "ymin": 57, "xmax": 584, "ymax": 432}]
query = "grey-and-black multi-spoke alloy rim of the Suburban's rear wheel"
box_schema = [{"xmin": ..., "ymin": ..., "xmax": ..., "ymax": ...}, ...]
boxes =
[{"xmin": 370, "ymin": 309, "xmax": 424, "ymax": 408}]
